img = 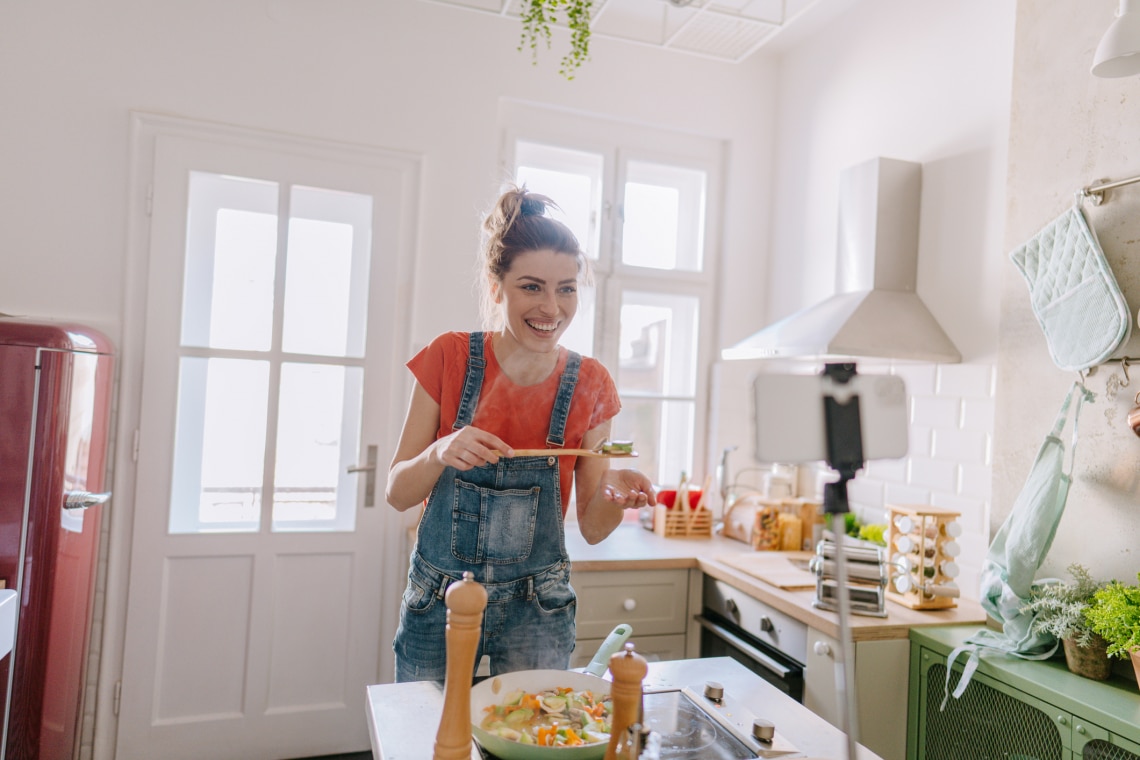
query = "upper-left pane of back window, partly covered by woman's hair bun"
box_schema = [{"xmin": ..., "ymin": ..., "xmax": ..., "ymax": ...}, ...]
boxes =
[{"xmin": 515, "ymin": 140, "xmax": 603, "ymax": 259}]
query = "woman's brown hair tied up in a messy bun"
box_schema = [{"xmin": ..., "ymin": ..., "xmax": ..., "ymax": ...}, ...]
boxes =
[{"xmin": 481, "ymin": 186, "xmax": 587, "ymax": 329}]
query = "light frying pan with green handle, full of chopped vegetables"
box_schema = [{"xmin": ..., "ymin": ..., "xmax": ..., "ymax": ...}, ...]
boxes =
[{"xmin": 471, "ymin": 624, "xmax": 632, "ymax": 760}]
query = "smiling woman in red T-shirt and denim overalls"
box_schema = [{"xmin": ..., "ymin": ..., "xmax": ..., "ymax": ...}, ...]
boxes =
[{"xmin": 388, "ymin": 188, "xmax": 656, "ymax": 681}]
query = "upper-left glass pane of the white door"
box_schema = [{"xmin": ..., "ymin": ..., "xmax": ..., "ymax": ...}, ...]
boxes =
[{"xmin": 181, "ymin": 172, "xmax": 277, "ymax": 351}]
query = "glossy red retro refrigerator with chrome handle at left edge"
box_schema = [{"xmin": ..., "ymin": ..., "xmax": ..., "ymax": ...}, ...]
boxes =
[{"xmin": 0, "ymin": 317, "xmax": 113, "ymax": 760}]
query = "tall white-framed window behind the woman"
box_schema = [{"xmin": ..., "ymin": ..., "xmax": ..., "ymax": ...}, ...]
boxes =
[{"xmin": 503, "ymin": 104, "xmax": 722, "ymax": 485}]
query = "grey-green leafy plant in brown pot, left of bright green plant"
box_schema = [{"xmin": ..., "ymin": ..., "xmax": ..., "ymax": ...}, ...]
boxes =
[{"xmin": 1021, "ymin": 563, "xmax": 1113, "ymax": 680}]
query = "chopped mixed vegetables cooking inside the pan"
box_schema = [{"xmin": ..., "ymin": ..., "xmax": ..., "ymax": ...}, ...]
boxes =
[{"xmin": 479, "ymin": 686, "xmax": 612, "ymax": 746}]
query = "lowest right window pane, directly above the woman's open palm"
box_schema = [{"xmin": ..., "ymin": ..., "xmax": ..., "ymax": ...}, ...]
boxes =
[{"xmin": 611, "ymin": 398, "xmax": 697, "ymax": 487}]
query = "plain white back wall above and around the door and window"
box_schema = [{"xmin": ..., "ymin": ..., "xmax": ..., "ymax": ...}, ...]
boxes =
[{"xmin": 0, "ymin": 0, "xmax": 773, "ymax": 757}]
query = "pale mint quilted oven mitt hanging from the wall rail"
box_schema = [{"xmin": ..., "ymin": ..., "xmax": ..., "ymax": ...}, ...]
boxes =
[{"xmin": 1010, "ymin": 204, "xmax": 1132, "ymax": 371}]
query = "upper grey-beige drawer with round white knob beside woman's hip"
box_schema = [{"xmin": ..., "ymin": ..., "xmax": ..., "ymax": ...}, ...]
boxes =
[{"xmin": 570, "ymin": 570, "xmax": 689, "ymax": 639}]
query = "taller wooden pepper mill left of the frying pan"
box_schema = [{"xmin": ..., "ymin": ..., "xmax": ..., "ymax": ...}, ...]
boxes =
[{"xmin": 432, "ymin": 572, "xmax": 487, "ymax": 760}]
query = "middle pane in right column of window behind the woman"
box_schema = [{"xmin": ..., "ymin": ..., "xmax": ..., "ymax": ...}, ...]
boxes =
[{"xmin": 618, "ymin": 291, "xmax": 700, "ymax": 397}]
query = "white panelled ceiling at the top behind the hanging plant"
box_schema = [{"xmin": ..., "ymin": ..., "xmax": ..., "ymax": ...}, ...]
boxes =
[{"xmin": 423, "ymin": 0, "xmax": 821, "ymax": 63}]
